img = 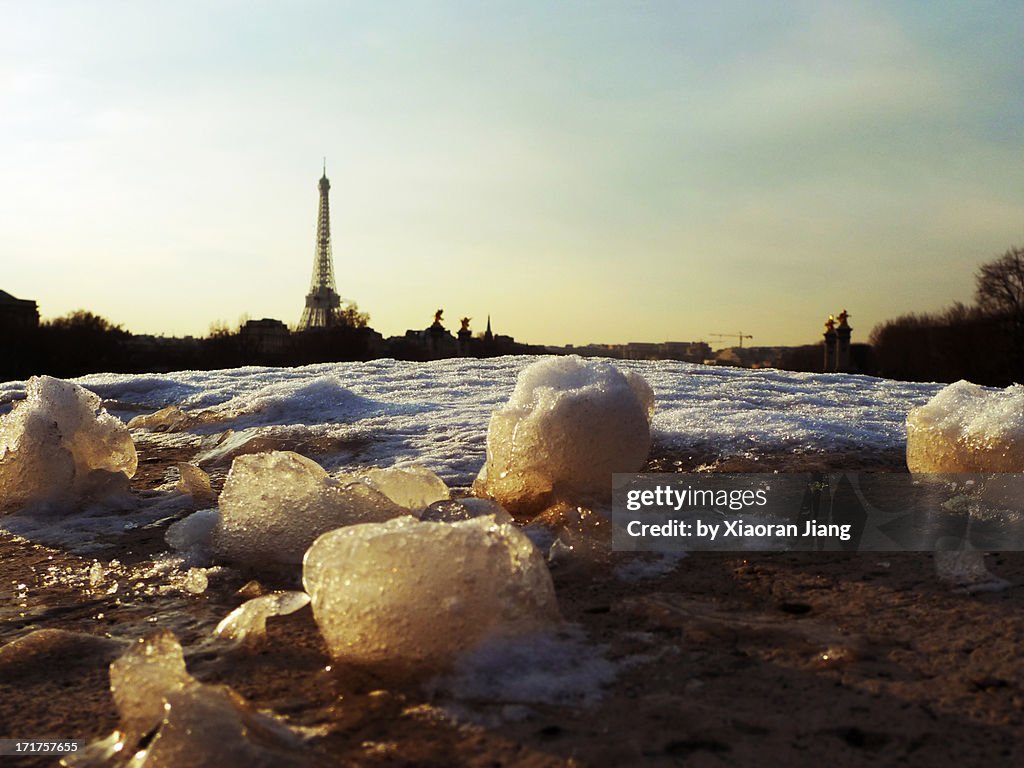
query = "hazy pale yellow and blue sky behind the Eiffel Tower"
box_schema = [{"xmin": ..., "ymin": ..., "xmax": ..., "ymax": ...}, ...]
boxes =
[{"xmin": 0, "ymin": 0, "xmax": 1024, "ymax": 346}]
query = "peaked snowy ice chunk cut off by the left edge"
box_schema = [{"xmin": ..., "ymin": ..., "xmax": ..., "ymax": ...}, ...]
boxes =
[{"xmin": 0, "ymin": 376, "xmax": 138, "ymax": 511}]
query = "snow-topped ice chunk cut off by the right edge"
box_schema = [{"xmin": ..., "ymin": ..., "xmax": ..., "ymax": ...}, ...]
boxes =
[{"xmin": 906, "ymin": 381, "xmax": 1024, "ymax": 472}]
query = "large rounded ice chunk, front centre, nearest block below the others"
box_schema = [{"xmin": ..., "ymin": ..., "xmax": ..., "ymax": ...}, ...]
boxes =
[{"xmin": 302, "ymin": 517, "xmax": 558, "ymax": 668}]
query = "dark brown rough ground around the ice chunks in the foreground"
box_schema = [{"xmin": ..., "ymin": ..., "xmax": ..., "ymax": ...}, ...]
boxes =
[{"xmin": 0, "ymin": 442, "xmax": 1024, "ymax": 766}]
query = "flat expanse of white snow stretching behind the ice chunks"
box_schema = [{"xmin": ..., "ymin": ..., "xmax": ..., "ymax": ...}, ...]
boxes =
[{"xmin": 0, "ymin": 356, "xmax": 942, "ymax": 485}]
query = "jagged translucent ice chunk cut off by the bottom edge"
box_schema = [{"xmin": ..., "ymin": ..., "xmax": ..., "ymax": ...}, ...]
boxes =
[{"xmin": 100, "ymin": 630, "xmax": 307, "ymax": 768}]
